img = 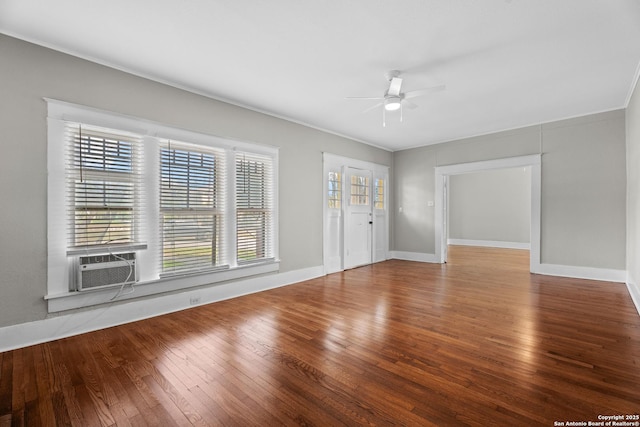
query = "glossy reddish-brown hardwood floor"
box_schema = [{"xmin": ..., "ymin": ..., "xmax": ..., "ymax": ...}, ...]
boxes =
[{"xmin": 0, "ymin": 246, "xmax": 640, "ymax": 426}]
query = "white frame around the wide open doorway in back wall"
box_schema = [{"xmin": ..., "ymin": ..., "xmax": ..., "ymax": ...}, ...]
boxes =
[{"xmin": 435, "ymin": 154, "xmax": 542, "ymax": 273}]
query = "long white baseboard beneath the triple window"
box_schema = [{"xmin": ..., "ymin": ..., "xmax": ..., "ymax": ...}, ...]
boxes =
[{"xmin": 0, "ymin": 266, "xmax": 324, "ymax": 352}]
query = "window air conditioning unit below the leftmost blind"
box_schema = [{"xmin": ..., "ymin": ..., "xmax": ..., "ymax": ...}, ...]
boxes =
[{"xmin": 76, "ymin": 252, "xmax": 137, "ymax": 291}]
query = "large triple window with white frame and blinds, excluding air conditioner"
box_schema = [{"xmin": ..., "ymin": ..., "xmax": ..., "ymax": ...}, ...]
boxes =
[{"xmin": 46, "ymin": 99, "xmax": 279, "ymax": 312}]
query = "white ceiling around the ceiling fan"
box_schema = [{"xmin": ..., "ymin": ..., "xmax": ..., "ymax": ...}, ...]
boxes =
[{"xmin": 0, "ymin": 0, "xmax": 640, "ymax": 150}]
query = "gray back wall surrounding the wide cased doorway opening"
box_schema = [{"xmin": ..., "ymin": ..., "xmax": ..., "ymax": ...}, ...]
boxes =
[{"xmin": 392, "ymin": 110, "xmax": 626, "ymax": 270}]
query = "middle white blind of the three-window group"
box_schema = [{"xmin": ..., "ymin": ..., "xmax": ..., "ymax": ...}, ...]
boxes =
[{"xmin": 160, "ymin": 141, "xmax": 227, "ymax": 274}]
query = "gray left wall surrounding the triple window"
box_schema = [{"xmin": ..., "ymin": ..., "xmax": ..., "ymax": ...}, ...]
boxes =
[{"xmin": 0, "ymin": 35, "xmax": 392, "ymax": 327}]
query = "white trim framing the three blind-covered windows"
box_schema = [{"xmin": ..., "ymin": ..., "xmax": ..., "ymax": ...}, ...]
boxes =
[{"xmin": 45, "ymin": 98, "xmax": 280, "ymax": 312}]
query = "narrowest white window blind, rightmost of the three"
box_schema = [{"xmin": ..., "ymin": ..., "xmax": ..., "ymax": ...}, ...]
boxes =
[{"xmin": 236, "ymin": 153, "xmax": 274, "ymax": 264}]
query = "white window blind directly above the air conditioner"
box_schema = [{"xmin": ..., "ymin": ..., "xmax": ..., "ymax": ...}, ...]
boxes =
[{"xmin": 65, "ymin": 123, "xmax": 142, "ymax": 250}]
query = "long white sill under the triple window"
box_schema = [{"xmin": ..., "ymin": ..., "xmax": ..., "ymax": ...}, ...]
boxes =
[{"xmin": 45, "ymin": 260, "xmax": 280, "ymax": 313}]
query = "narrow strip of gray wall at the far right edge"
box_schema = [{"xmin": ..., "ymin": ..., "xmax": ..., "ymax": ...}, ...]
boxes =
[{"xmin": 627, "ymin": 76, "xmax": 640, "ymax": 286}]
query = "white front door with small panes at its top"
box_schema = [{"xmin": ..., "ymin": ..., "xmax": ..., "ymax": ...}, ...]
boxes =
[{"xmin": 344, "ymin": 168, "xmax": 373, "ymax": 269}]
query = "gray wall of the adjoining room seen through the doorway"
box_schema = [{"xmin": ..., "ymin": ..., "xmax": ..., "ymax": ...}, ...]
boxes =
[{"xmin": 447, "ymin": 167, "xmax": 531, "ymax": 243}]
